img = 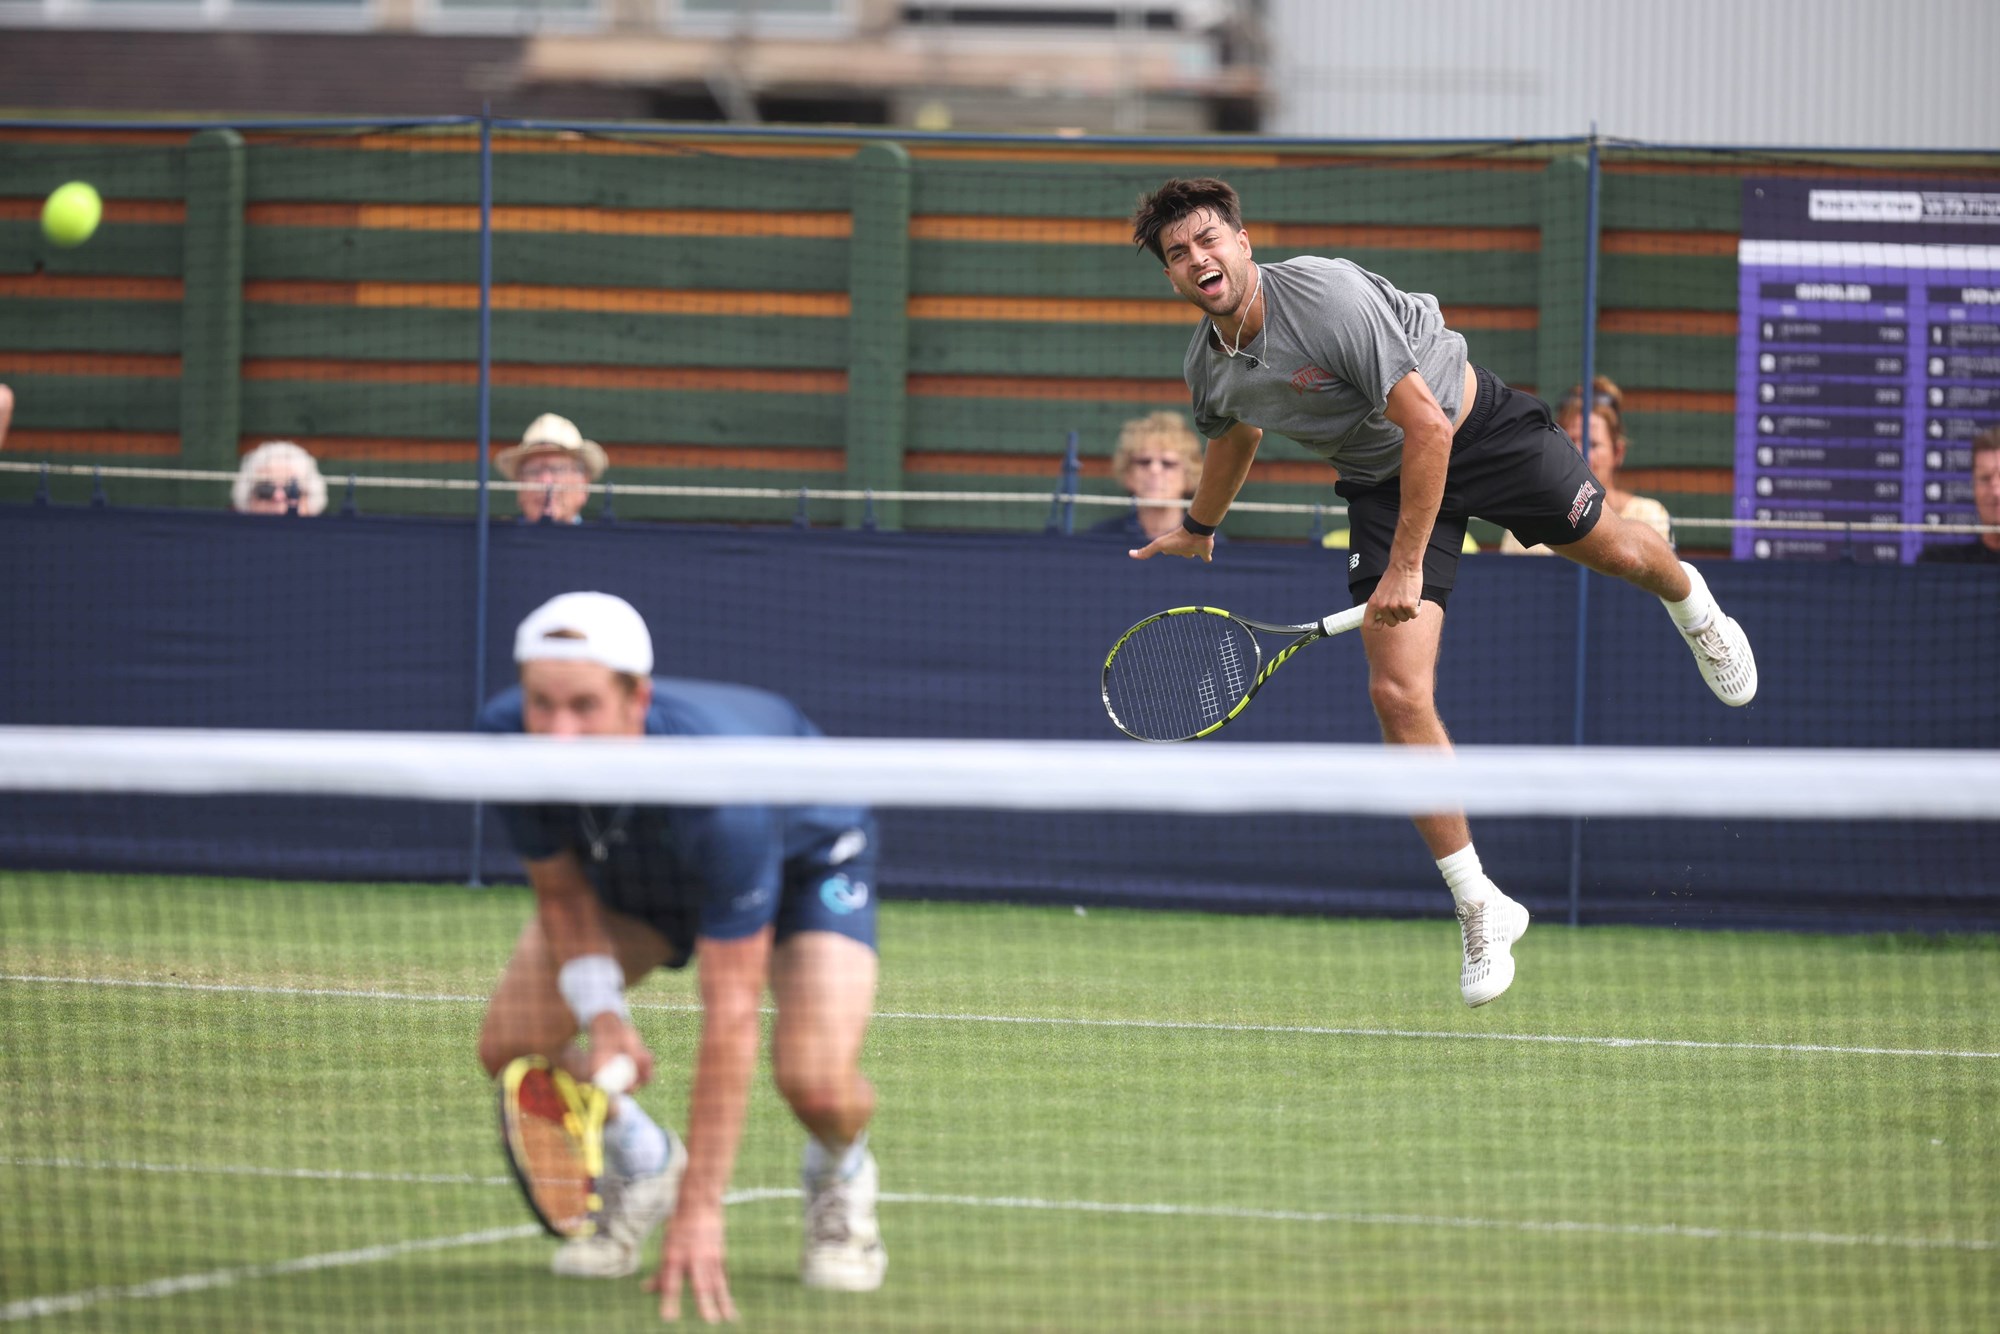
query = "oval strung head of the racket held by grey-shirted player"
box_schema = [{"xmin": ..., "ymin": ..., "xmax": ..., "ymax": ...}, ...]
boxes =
[{"xmin": 1104, "ymin": 612, "xmax": 1258, "ymax": 742}]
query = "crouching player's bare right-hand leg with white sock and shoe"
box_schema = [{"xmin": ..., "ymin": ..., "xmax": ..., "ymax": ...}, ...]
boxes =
[{"xmin": 772, "ymin": 930, "xmax": 888, "ymax": 1292}]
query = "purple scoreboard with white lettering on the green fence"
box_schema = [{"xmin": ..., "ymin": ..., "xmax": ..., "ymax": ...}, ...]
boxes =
[{"xmin": 1734, "ymin": 178, "xmax": 2000, "ymax": 560}]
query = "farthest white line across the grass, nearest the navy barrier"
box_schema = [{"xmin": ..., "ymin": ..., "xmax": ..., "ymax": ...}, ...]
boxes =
[{"xmin": 0, "ymin": 972, "xmax": 2000, "ymax": 1060}]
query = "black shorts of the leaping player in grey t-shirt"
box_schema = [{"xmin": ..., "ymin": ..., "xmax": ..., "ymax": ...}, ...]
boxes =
[{"xmin": 1334, "ymin": 366, "xmax": 1604, "ymax": 608}]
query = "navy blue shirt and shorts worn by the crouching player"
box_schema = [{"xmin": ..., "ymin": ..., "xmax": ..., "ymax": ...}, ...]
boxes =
[{"xmin": 476, "ymin": 678, "xmax": 874, "ymax": 946}]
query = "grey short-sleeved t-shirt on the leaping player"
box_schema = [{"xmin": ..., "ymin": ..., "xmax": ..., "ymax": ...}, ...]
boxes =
[{"xmin": 1182, "ymin": 254, "xmax": 1466, "ymax": 486}]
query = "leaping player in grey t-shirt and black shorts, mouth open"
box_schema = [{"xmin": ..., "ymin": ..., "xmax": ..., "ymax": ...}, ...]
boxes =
[{"xmin": 1132, "ymin": 178, "xmax": 1756, "ymax": 1006}]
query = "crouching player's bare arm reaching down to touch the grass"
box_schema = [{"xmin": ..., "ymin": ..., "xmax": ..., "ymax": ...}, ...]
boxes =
[{"xmin": 646, "ymin": 926, "xmax": 772, "ymax": 1324}]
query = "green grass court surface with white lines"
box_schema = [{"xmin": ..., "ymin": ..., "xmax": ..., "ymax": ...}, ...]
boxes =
[{"xmin": 0, "ymin": 872, "xmax": 2000, "ymax": 1332}]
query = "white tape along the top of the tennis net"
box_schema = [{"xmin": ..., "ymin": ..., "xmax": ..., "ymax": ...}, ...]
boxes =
[{"xmin": 0, "ymin": 728, "xmax": 2000, "ymax": 820}]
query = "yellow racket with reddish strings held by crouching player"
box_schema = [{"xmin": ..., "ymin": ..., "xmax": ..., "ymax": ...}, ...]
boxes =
[{"xmin": 500, "ymin": 1054, "xmax": 638, "ymax": 1238}]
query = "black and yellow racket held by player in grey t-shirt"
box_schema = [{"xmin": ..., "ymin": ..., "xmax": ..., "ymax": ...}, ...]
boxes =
[{"xmin": 1104, "ymin": 604, "xmax": 1368, "ymax": 742}]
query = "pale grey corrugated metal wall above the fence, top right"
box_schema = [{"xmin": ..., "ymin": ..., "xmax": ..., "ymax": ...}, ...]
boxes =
[{"xmin": 1266, "ymin": 0, "xmax": 2000, "ymax": 148}]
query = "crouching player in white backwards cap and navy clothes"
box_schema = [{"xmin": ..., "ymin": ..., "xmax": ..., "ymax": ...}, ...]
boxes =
[{"xmin": 478, "ymin": 592, "xmax": 888, "ymax": 1320}]
